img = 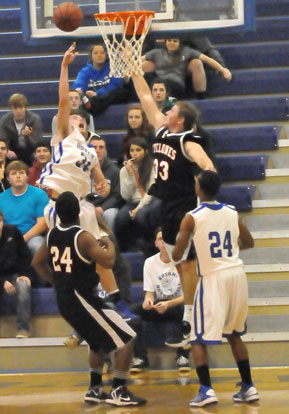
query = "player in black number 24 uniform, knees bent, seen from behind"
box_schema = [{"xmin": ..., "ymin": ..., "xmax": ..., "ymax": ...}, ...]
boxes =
[{"xmin": 32, "ymin": 191, "xmax": 146, "ymax": 406}]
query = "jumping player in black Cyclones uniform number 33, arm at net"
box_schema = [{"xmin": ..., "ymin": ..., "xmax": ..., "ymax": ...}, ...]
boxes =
[{"xmin": 132, "ymin": 70, "xmax": 215, "ymax": 347}]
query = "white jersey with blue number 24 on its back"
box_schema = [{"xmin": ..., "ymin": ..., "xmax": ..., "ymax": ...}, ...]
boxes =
[{"xmin": 187, "ymin": 201, "xmax": 243, "ymax": 276}]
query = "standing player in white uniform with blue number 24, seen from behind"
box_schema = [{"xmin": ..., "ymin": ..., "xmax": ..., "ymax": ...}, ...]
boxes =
[{"xmin": 172, "ymin": 171, "xmax": 259, "ymax": 407}]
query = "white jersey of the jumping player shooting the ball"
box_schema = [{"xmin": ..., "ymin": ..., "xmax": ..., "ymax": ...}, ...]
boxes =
[{"xmin": 38, "ymin": 126, "xmax": 98, "ymax": 198}]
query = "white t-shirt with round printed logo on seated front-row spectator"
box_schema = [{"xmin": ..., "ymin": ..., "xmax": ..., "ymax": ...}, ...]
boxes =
[{"xmin": 144, "ymin": 253, "xmax": 183, "ymax": 300}]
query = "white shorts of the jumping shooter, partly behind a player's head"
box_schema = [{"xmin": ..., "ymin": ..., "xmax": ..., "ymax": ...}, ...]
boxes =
[{"xmin": 44, "ymin": 199, "xmax": 107, "ymax": 239}]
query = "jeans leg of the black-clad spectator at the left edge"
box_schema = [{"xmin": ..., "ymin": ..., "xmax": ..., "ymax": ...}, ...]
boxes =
[{"xmin": 9, "ymin": 274, "xmax": 31, "ymax": 331}]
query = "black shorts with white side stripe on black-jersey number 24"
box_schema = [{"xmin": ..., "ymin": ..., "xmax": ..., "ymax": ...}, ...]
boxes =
[{"xmin": 57, "ymin": 291, "xmax": 136, "ymax": 353}]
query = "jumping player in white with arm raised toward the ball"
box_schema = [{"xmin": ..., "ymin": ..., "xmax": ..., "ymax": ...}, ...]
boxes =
[{"xmin": 39, "ymin": 43, "xmax": 119, "ymax": 302}]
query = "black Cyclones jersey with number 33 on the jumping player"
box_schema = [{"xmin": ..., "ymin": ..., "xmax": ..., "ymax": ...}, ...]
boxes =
[{"xmin": 148, "ymin": 126, "xmax": 203, "ymax": 200}]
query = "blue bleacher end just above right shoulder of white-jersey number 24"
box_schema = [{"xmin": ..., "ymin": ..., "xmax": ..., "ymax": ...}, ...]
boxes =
[{"xmin": 217, "ymin": 185, "xmax": 256, "ymax": 211}]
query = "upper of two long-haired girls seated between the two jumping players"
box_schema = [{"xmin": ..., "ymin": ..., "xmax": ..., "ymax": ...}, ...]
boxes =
[{"xmin": 118, "ymin": 104, "xmax": 154, "ymax": 165}]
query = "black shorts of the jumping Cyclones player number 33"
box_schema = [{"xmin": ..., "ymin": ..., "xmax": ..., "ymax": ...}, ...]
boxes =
[{"xmin": 161, "ymin": 197, "xmax": 197, "ymax": 259}]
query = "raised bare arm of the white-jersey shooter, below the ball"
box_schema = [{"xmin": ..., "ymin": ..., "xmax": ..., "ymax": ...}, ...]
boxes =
[{"xmin": 54, "ymin": 42, "xmax": 78, "ymax": 144}]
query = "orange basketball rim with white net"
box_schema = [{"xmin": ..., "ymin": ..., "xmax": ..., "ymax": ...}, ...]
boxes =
[{"xmin": 94, "ymin": 10, "xmax": 155, "ymax": 78}]
